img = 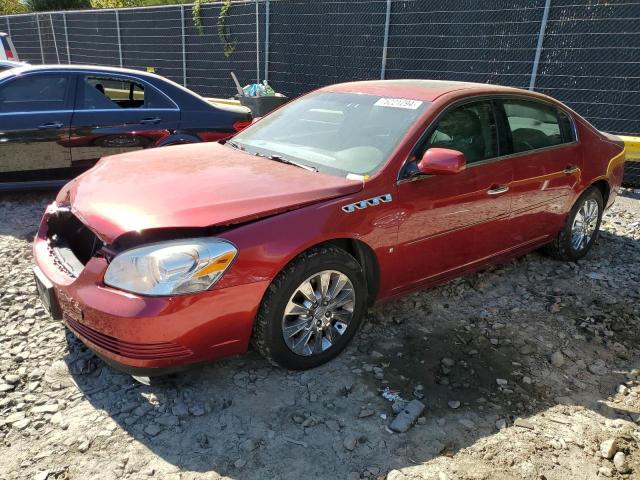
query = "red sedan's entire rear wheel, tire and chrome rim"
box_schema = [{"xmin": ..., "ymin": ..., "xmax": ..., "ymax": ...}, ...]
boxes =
[{"xmin": 547, "ymin": 187, "xmax": 604, "ymax": 262}]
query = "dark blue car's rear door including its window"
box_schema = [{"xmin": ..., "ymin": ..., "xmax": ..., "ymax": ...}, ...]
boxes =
[{"xmin": 69, "ymin": 73, "xmax": 180, "ymax": 165}]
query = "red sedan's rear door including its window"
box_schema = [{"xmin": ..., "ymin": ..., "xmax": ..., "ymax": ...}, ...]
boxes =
[{"xmin": 497, "ymin": 98, "xmax": 581, "ymax": 244}]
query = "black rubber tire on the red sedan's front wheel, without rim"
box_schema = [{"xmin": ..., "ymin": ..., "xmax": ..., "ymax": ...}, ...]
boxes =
[{"xmin": 252, "ymin": 246, "xmax": 367, "ymax": 370}]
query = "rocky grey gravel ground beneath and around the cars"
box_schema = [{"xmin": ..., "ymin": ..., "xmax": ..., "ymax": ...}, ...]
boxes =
[{"xmin": 0, "ymin": 190, "xmax": 640, "ymax": 480}]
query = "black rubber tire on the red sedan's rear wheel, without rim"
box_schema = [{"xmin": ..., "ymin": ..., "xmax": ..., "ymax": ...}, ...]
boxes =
[{"xmin": 546, "ymin": 187, "xmax": 604, "ymax": 262}]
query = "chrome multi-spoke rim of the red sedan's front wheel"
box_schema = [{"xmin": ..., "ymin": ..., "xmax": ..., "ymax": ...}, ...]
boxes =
[{"xmin": 282, "ymin": 270, "xmax": 355, "ymax": 356}]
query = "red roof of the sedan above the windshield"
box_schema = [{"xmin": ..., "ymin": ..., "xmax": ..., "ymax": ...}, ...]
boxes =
[{"xmin": 320, "ymin": 79, "xmax": 528, "ymax": 102}]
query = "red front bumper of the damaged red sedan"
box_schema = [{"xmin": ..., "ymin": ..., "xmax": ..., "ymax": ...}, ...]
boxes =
[{"xmin": 34, "ymin": 208, "xmax": 268, "ymax": 375}]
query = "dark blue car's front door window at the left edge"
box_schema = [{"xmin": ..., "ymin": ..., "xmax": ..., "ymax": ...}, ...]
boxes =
[{"xmin": 0, "ymin": 73, "xmax": 69, "ymax": 113}]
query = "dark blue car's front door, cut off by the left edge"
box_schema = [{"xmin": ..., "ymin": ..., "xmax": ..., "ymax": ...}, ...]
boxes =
[{"xmin": 0, "ymin": 72, "xmax": 74, "ymax": 182}]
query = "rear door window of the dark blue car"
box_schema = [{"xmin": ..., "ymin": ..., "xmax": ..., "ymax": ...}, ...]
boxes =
[{"xmin": 80, "ymin": 75, "xmax": 175, "ymax": 110}]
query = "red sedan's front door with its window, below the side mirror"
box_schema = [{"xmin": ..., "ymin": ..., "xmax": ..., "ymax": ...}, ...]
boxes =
[{"xmin": 398, "ymin": 101, "xmax": 513, "ymax": 290}]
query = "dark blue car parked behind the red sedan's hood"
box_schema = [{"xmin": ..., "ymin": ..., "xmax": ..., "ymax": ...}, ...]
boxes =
[{"xmin": 0, "ymin": 65, "xmax": 251, "ymax": 190}]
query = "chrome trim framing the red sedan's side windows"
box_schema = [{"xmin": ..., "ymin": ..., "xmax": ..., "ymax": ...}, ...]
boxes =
[{"xmin": 396, "ymin": 93, "xmax": 580, "ymax": 185}]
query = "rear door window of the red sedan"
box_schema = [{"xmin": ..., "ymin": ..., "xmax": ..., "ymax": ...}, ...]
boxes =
[{"xmin": 502, "ymin": 100, "xmax": 575, "ymax": 153}]
